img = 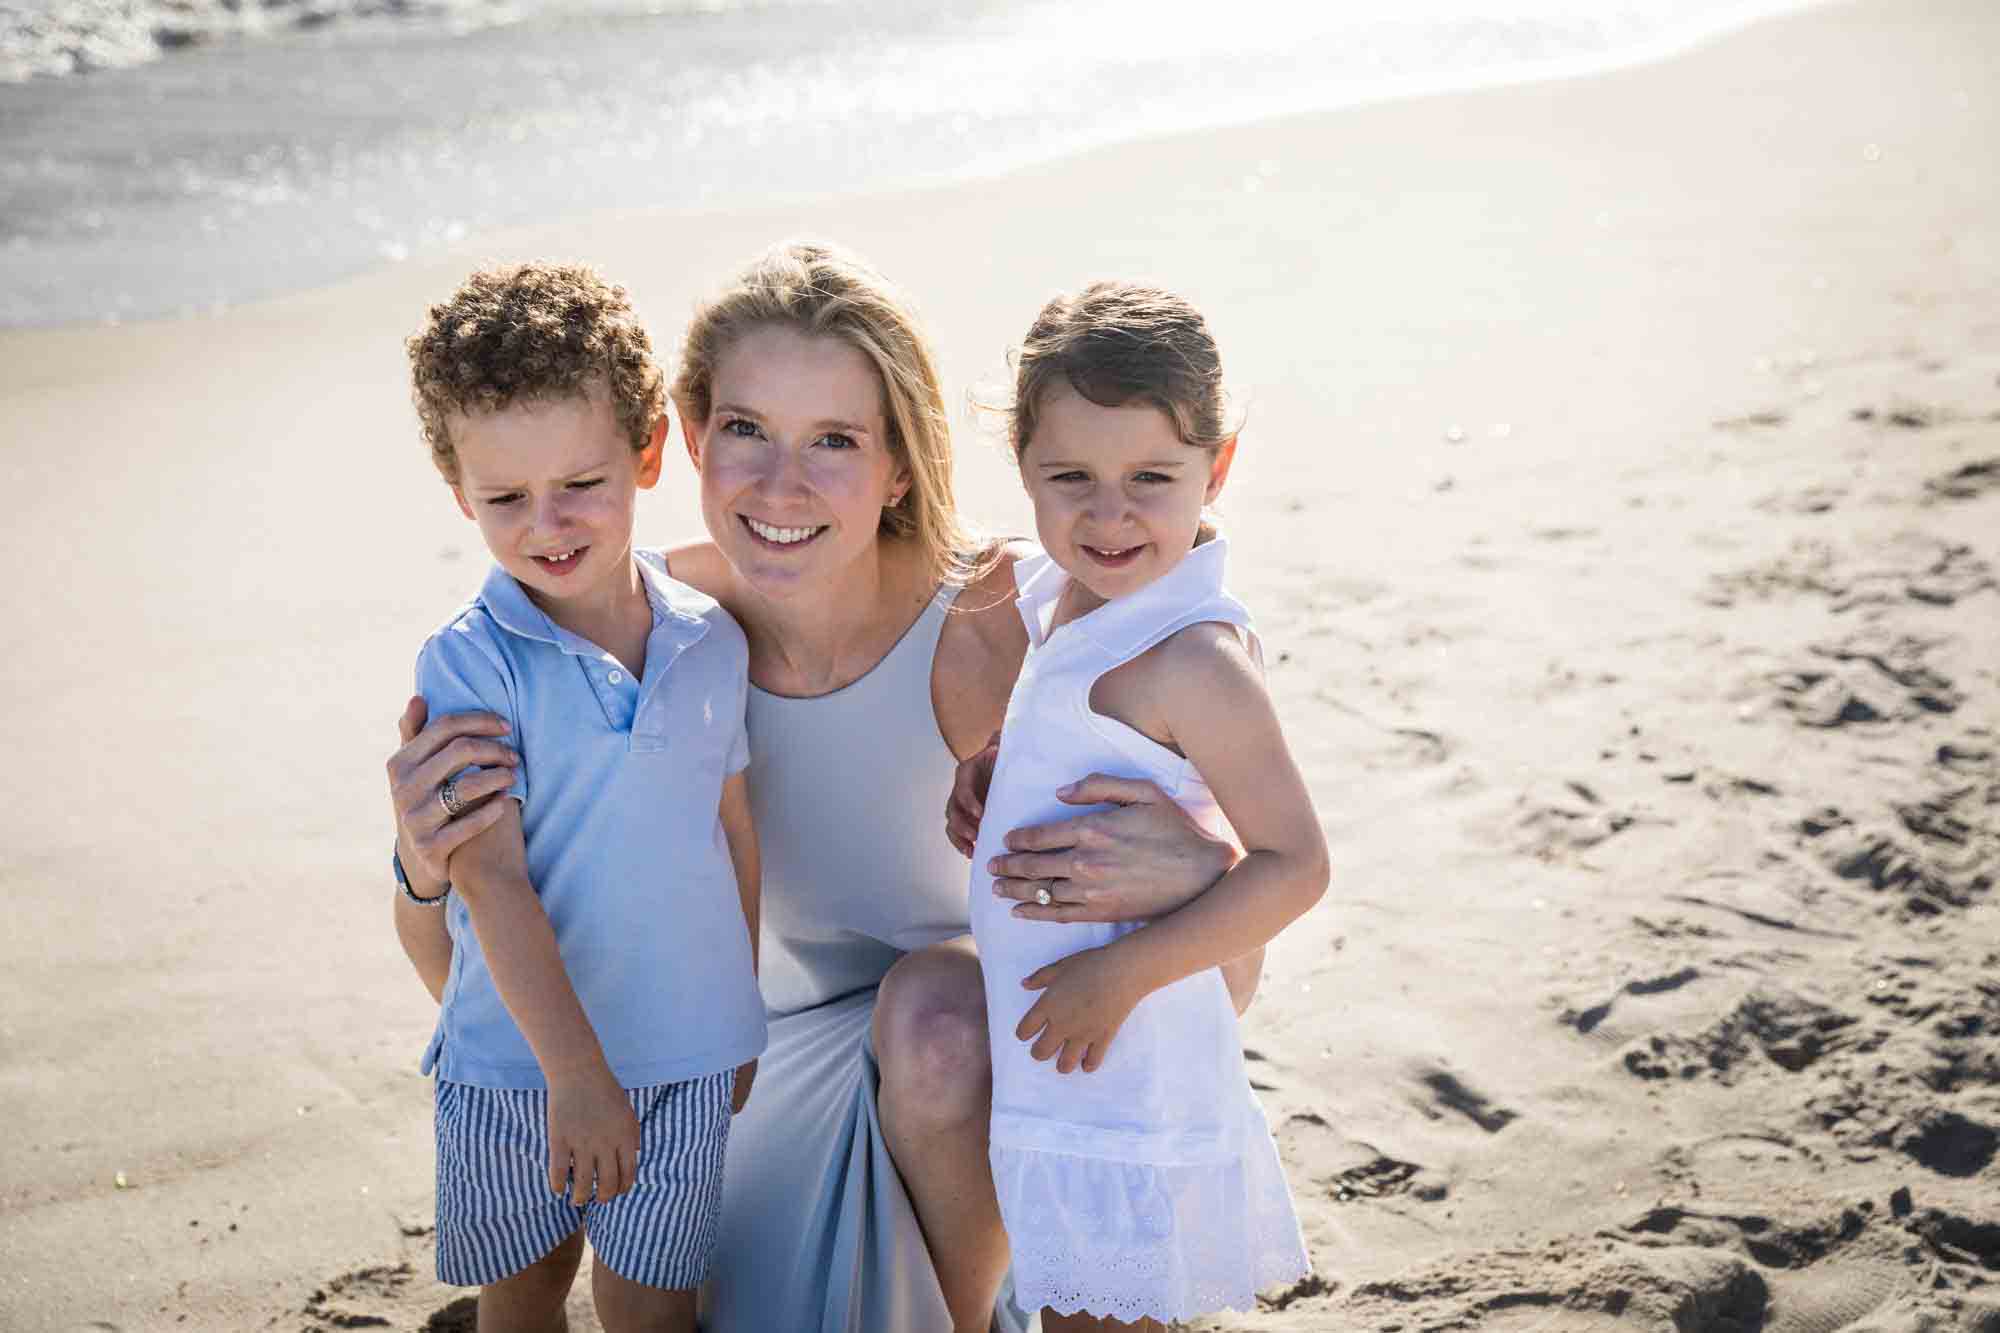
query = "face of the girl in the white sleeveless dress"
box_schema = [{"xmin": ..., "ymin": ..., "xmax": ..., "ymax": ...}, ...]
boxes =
[{"xmin": 1020, "ymin": 384, "xmax": 1236, "ymax": 610}]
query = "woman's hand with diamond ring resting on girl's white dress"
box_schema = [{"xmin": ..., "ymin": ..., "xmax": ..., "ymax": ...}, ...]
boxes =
[{"xmin": 984, "ymin": 772, "xmax": 1238, "ymax": 921}]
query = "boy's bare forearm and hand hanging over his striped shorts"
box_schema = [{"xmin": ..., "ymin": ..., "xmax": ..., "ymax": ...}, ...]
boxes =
[{"xmin": 448, "ymin": 801, "xmax": 638, "ymax": 1205}]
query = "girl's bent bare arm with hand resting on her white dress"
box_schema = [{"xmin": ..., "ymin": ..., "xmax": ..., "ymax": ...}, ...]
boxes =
[{"xmin": 1014, "ymin": 624, "xmax": 1328, "ymax": 1073}]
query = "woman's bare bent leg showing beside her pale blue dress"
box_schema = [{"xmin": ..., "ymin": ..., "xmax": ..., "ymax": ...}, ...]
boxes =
[{"xmin": 874, "ymin": 935, "xmax": 1008, "ymax": 1333}]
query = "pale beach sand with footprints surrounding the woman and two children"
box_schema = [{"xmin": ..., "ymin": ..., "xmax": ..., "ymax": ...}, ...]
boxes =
[{"xmin": 0, "ymin": 0, "xmax": 2000, "ymax": 1333}]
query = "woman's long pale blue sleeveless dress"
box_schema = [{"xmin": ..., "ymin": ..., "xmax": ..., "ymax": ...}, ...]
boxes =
[{"xmin": 702, "ymin": 588, "xmax": 1022, "ymax": 1333}]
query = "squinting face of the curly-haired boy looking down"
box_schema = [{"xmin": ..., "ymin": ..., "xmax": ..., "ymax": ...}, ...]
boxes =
[{"xmin": 450, "ymin": 388, "xmax": 666, "ymax": 606}]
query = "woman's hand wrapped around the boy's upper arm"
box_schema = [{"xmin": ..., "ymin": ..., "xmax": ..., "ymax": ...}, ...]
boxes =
[{"xmin": 388, "ymin": 699, "xmax": 520, "ymax": 897}]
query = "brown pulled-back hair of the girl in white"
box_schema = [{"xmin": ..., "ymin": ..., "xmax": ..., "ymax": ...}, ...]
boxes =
[{"xmin": 1008, "ymin": 282, "xmax": 1242, "ymax": 458}]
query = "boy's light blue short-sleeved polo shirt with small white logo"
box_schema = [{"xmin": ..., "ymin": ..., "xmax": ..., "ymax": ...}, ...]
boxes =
[{"xmin": 416, "ymin": 550, "xmax": 764, "ymax": 1089}]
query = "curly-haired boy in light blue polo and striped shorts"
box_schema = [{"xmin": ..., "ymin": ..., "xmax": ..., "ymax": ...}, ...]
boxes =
[{"xmin": 398, "ymin": 264, "xmax": 764, "ymax": 1331}]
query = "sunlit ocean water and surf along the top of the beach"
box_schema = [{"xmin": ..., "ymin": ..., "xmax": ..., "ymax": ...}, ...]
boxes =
[{"xmin": 0, "ymin": 0, "xmax": 1812, "ymax": 326}]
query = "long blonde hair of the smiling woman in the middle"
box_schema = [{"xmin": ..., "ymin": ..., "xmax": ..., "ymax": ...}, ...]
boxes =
[{"xmin": 670, "ymin": 240, "xmax": 990, "ymax": 582}]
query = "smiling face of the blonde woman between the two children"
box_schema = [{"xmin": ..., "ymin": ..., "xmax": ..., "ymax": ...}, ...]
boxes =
[{"xmin": 686, "ymin": 326, "xmax": 910, "ymax": 598}]
